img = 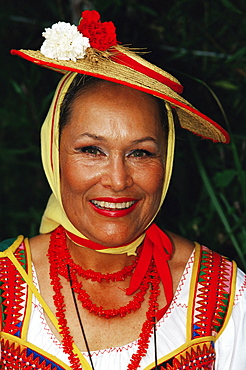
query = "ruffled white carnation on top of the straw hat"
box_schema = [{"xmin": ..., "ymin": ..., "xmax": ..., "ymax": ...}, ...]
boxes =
[{"xmin": 40, "ymin": 22, "xmax": 90, "ymax": 62}]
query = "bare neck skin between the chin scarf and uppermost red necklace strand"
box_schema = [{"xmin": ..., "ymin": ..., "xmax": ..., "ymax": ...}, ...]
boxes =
[{"xmin": 66, "ymin": 238, "xmax": 135, "ymax": 273}]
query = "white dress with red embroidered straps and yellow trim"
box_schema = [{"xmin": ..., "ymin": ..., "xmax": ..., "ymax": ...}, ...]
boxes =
[{"xmin": 0, "ymin": 237, "xmax": 246, "ymax": 370}]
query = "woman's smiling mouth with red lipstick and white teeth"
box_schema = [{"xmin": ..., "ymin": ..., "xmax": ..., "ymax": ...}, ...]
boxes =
[{"xmin": 90, "ymin": 198, "xmax": 138, "ymax": 217}]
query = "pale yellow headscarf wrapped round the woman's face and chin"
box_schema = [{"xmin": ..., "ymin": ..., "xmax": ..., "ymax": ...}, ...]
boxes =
[{"xmin": 40, "ymin": 72, "xmax": 175, "ymax": 255}]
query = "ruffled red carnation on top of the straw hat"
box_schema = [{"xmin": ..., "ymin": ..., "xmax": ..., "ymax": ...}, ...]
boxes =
[{"xmin": 78, "ymin": 10, "xmax": 117, "ymax": 51}]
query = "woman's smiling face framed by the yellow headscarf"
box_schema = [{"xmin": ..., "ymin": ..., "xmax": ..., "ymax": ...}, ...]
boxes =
[{"xmin": 60, "ymin": 82, "xmax": 166, "ymax": 247}]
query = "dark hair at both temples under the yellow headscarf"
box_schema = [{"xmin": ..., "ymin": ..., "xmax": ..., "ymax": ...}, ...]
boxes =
[{"xmin": 59, "ymin": 74, "xmax": 168, "ymax": 137}]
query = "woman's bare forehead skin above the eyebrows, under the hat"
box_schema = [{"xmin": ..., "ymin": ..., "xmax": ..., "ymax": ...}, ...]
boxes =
[{"xmin": 70, "ymin": 80, "xmax": 165, "ymax": 132}]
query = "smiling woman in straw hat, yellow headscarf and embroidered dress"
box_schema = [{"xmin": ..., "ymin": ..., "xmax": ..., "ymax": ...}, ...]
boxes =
[{"xmin": 1, "ymin": 11, "xmax": 246, "ymax": 370}]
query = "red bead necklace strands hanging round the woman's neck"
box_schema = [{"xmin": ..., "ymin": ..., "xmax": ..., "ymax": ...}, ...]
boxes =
[{"xmin": 48, "ymin": 226, "xmax": 160, "ymax": 370}]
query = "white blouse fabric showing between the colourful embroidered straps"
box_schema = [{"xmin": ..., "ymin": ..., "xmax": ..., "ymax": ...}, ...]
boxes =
[{"xmin": 27, "ymin": 253, "xmax": 246, "ymax": 370}]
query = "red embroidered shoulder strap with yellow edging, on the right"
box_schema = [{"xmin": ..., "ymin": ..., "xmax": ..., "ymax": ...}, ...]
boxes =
[{"xmin": 188, "ymin": 246, "xmax": 235, "ymax": 339}]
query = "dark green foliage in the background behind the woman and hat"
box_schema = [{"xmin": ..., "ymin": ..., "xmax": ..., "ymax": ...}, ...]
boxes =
[{"xmin": 0, "ymin": 0, "xmax": 246, "ymax": 269}]
